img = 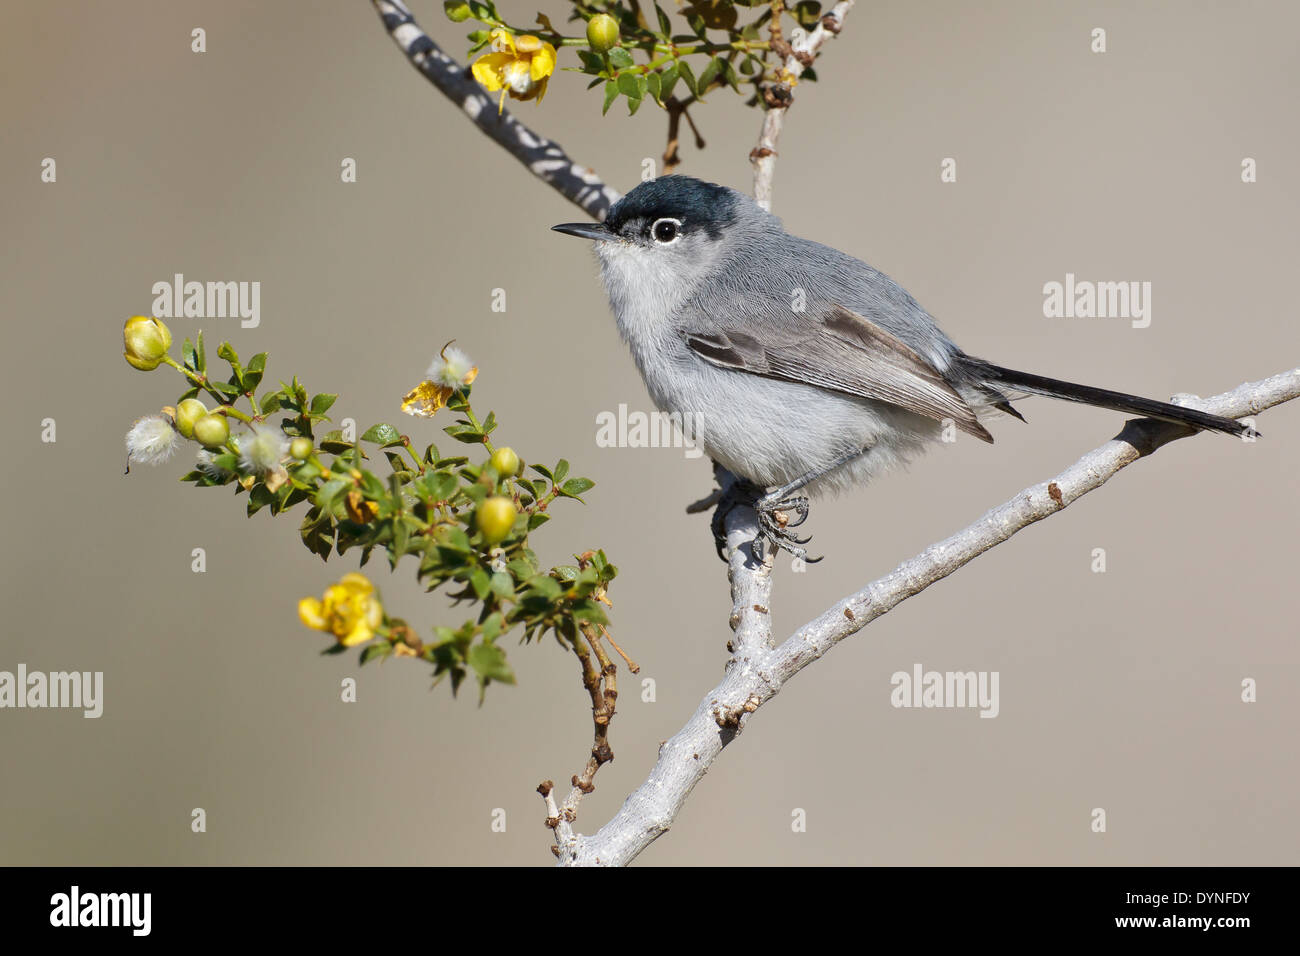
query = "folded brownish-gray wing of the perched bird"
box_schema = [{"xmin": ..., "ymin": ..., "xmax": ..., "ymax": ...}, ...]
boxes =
[{"xmin": 686, "ymin": 306, "xmax": 993, "ymax": 442}]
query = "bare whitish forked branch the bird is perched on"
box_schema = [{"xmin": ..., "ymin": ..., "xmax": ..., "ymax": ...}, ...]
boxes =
[{"xmin": 559, "ymin": 368, "xmax": 1300, "ymax": 866}]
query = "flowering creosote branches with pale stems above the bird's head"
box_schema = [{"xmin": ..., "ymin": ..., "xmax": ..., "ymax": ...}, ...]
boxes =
[{"xmin": 372, "ymin": 0, "xmax": 853, "ymax": 219}]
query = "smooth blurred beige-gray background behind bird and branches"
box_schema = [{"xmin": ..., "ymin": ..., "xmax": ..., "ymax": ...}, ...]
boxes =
[{"xmin": 0, "ymin": 0, "xmax": 1300, "ymax": 865}]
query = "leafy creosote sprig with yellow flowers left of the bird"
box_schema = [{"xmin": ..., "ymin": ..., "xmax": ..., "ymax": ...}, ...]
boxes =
[{"xmin": 124, "ymin": 316, "xmax": 618, "ymax": 712}]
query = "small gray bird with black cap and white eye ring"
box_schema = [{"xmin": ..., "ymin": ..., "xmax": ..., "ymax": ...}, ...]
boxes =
[{"xmin": 553, "ymin": 176, "xmax": 1258, "ymax": 561}]
